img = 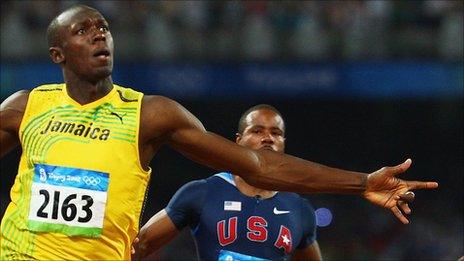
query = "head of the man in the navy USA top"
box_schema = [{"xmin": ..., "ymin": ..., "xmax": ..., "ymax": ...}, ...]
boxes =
[{"xmin": 237, "ymin": 109, "xmax": 285, "ymax": 152}]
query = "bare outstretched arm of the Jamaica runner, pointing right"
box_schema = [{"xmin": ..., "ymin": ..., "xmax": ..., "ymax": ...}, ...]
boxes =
[{"xmin": 142, "ymin": 96, "xmax": 438, "ymax": 222}]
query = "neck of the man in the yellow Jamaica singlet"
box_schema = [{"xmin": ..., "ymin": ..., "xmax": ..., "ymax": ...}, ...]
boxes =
[{"xmin": 65, "ymin": 72, "xmax": 113, "ymax": 105}]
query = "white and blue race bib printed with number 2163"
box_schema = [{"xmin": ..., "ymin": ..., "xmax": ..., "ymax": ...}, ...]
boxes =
[{"xmin": 28, "ymin": 164, "xmax": 109, "ymax": 237}]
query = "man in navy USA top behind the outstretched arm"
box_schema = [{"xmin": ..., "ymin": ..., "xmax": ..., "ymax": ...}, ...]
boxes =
[{"xmin": 134, "ymin": 105, "xmax": 322, "ymax": 261}]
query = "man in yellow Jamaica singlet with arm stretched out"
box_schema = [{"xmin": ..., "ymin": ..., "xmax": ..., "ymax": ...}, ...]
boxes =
[{"xmin": 0, "ymin": 5, "xmax": 438, "ymax": 260}]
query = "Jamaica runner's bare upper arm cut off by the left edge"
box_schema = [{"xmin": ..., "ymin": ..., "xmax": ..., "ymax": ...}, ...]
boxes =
[{"xmin": 0, "ymin": 91, "xmax": 29, "ymax": 158}]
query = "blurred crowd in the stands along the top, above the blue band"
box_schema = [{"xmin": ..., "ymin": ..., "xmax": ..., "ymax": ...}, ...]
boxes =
[{"xmin": 1, "ymin": 0, "xmax": 463, "ymax": 61}]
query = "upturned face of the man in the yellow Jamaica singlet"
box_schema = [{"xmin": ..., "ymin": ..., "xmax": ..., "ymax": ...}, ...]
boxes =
[{"xmin": 56, "ymin": 9, "xmax": 114, "ymax": 81}]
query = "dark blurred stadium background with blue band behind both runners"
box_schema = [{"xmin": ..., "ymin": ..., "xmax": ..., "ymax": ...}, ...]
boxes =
[{"xmin": 0, "ymin": 0, "xmax": 464, "ymax": 260}]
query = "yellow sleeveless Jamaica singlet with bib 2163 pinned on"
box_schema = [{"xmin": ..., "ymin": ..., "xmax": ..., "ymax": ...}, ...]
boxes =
[{"xmin": 0, "ymin": 84, "xmax": 151, "ymax": 260}]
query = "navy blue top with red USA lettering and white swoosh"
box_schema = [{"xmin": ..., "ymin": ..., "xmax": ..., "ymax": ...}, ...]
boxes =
[{"xmin": 166, "ymin": 172, "xmax": 316, "ymax": 260}]
